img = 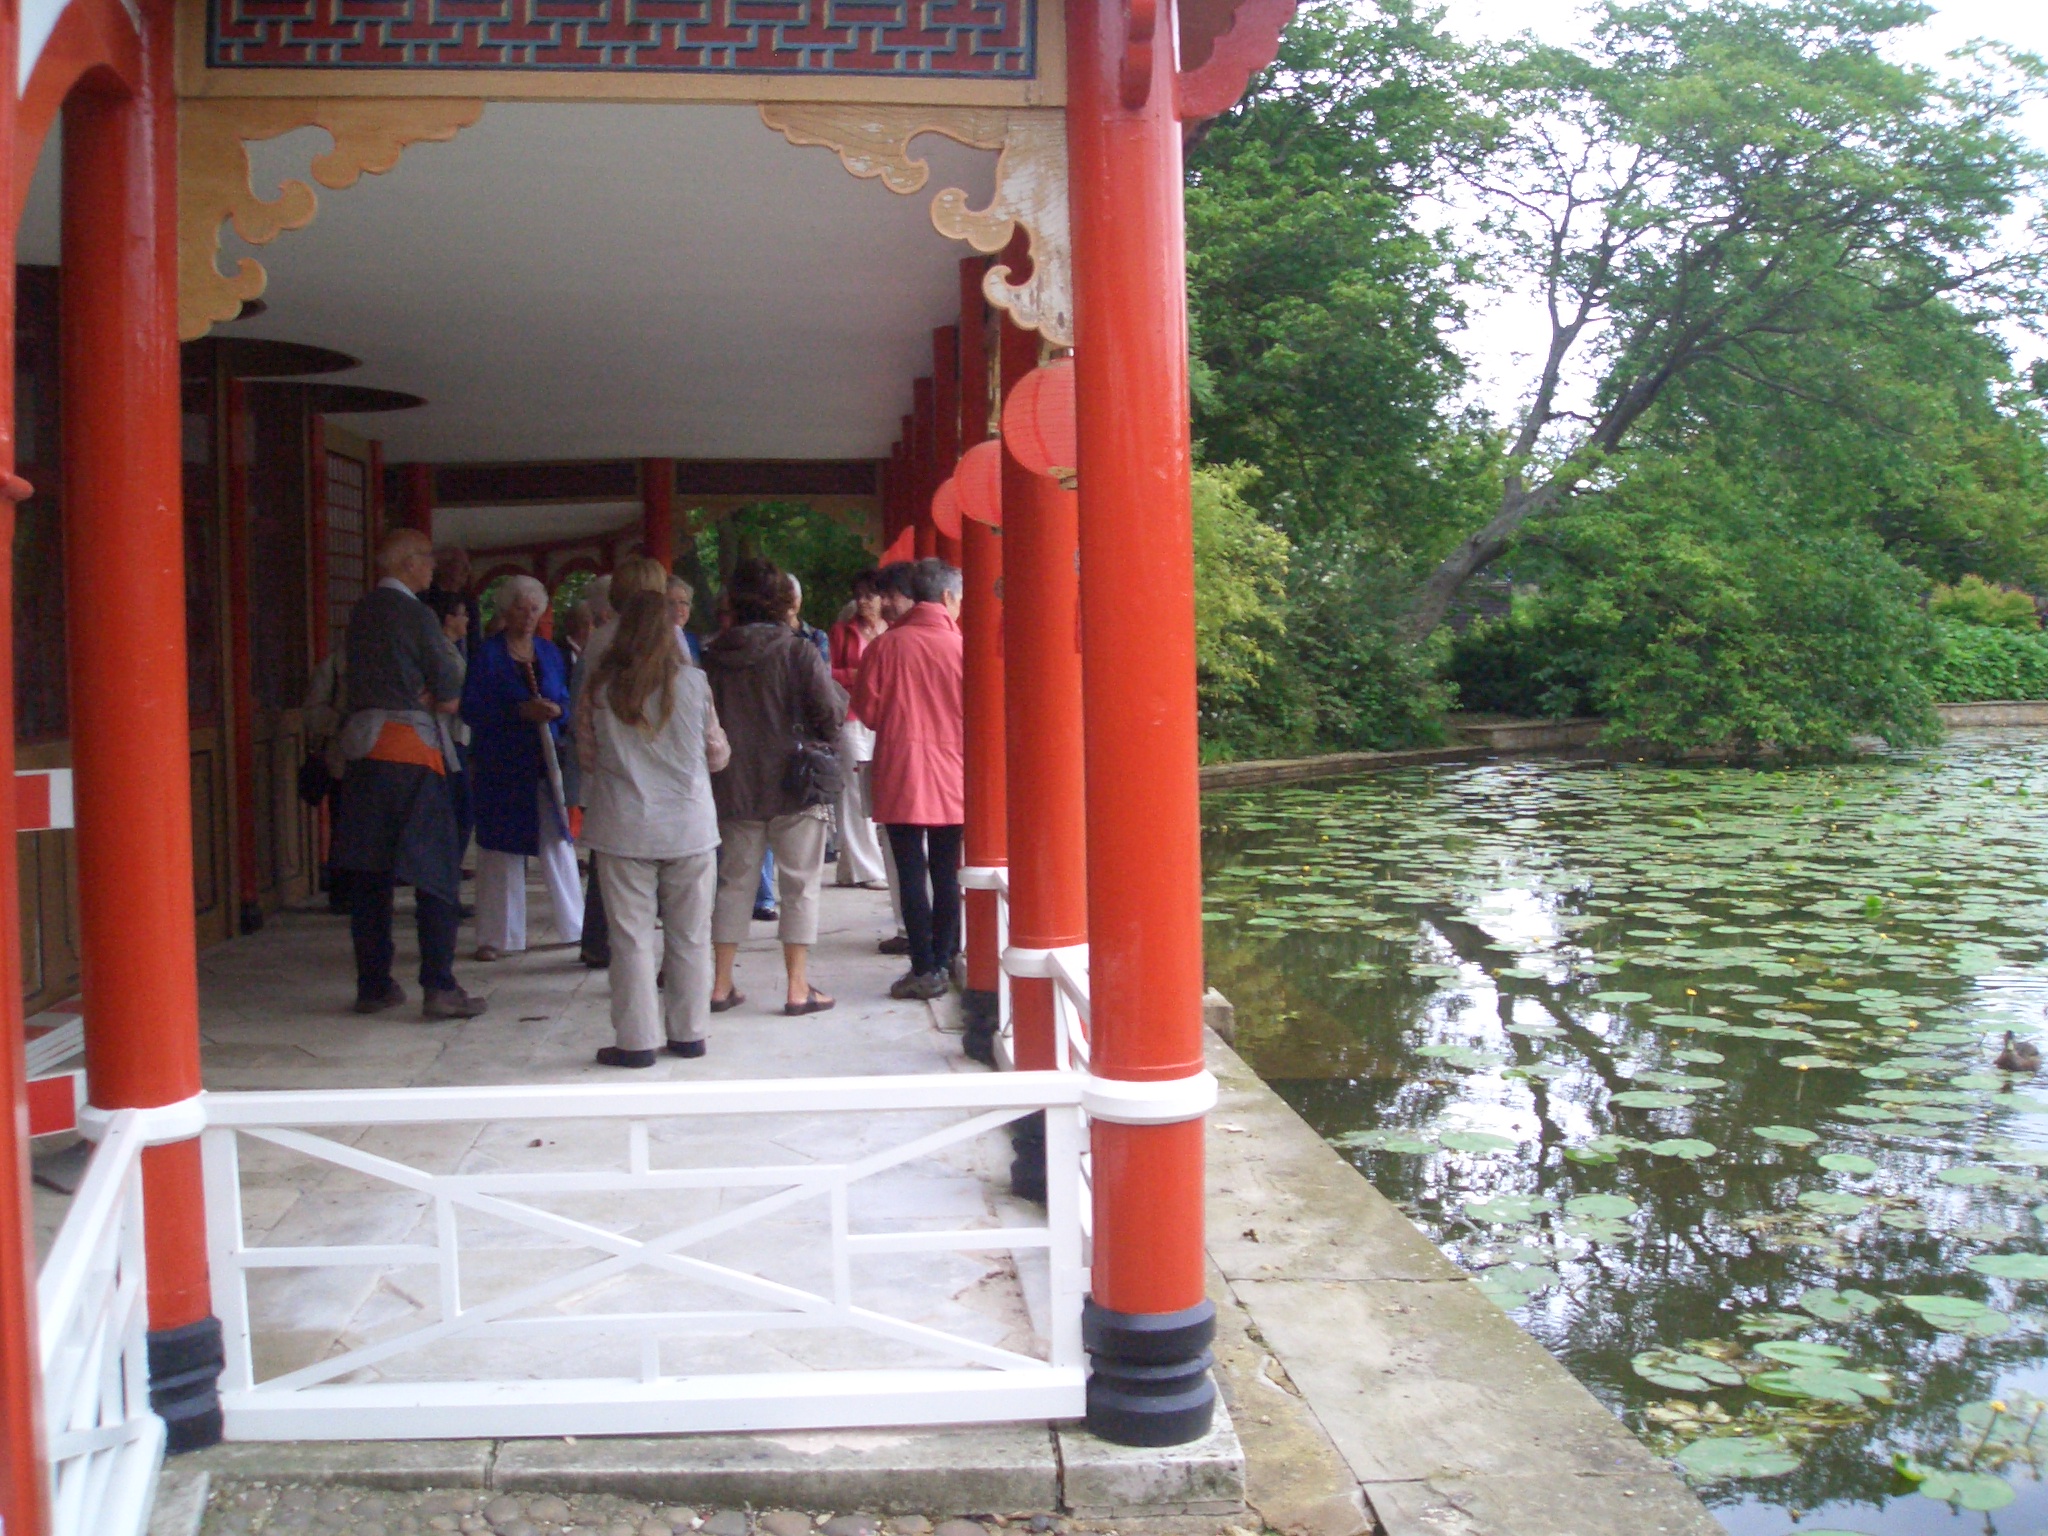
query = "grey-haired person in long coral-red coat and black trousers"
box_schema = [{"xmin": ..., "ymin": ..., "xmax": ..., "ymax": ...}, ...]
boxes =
[{"xmin": 852, "ymin": 559, "xmax": 967, "ymax": 997}]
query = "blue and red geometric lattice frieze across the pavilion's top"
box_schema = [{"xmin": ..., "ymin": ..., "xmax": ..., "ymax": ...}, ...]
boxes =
[{"xmin": 207, "ymin": 0, "xmax": 1036, "ymax": 80}]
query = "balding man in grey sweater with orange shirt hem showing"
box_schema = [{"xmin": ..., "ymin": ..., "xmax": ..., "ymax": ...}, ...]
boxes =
[{"xmin": 334, "ymin": 528, "xmax": 485, "ymax": 1018}]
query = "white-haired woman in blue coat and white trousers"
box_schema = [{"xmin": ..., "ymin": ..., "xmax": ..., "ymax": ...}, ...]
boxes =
[{"xmin": 463, "ymin": 575, "xmax": 584, "ymax": 961}]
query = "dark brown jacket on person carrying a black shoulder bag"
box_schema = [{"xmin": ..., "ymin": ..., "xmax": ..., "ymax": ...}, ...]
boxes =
[{"xmin": 705, "ymin": 625, "xmax": 846, "ymax": 821}]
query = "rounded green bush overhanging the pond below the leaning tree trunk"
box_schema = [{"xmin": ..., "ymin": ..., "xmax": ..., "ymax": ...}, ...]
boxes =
[{"xmin": 1454, "ymin": 459, "xmax": 1933, "ymax": 754}]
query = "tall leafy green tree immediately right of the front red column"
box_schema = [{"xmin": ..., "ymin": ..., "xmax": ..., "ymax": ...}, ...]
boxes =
[{"xmin": 1188, "ymin": 0, "xmax": 1487, "ymax": 565}]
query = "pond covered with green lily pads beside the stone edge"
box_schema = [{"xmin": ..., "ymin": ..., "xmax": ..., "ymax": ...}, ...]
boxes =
[{"xmin": 1204, "ymin": 731, "xmax": 2048, "ymax": 1536}]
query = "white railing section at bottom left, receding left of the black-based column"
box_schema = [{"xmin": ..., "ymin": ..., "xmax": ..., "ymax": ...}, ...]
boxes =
[{"xmin": 35, "ymin": 1110, "xmax": 164, "ymax": 1536}]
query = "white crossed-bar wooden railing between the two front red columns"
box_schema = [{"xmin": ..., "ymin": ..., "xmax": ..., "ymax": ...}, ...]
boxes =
[{"xmin": 203, "ymin": 1071, "xmax": 1087, "ymax": 1440}]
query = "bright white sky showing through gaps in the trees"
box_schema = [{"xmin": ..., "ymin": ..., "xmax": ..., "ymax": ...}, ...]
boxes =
[{"xmin": 1438, "ymin": 0, "xmax": 2048, "ymax": 420}]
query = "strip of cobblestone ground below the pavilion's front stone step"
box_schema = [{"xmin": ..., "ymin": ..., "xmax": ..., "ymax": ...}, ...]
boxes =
[{"xmin": 199, "ymin": 1483, "xmax": 1257, "ymax": 1536}]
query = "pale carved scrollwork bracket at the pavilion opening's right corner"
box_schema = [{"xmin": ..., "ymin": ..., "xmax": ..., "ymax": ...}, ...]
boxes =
[{"xmin": 760, "ymin": 102, "xmax": 1073, "ymax": 346}]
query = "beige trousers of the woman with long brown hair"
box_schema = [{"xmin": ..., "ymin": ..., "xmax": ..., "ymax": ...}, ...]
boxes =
[{"xmin": 598, "ymin": 852, "xmax": 719, "ymax": 1051}]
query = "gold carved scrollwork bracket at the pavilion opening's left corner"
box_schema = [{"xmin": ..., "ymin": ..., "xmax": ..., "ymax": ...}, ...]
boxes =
[{"xmin": 178, "ymin": 98, "xmax": 483, "ymax": 342}]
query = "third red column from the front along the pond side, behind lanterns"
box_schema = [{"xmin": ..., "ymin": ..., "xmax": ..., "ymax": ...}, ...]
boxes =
[{"xmin": 948, "ymin": 258, "xmax": 1010, "ymax": 1065}]
